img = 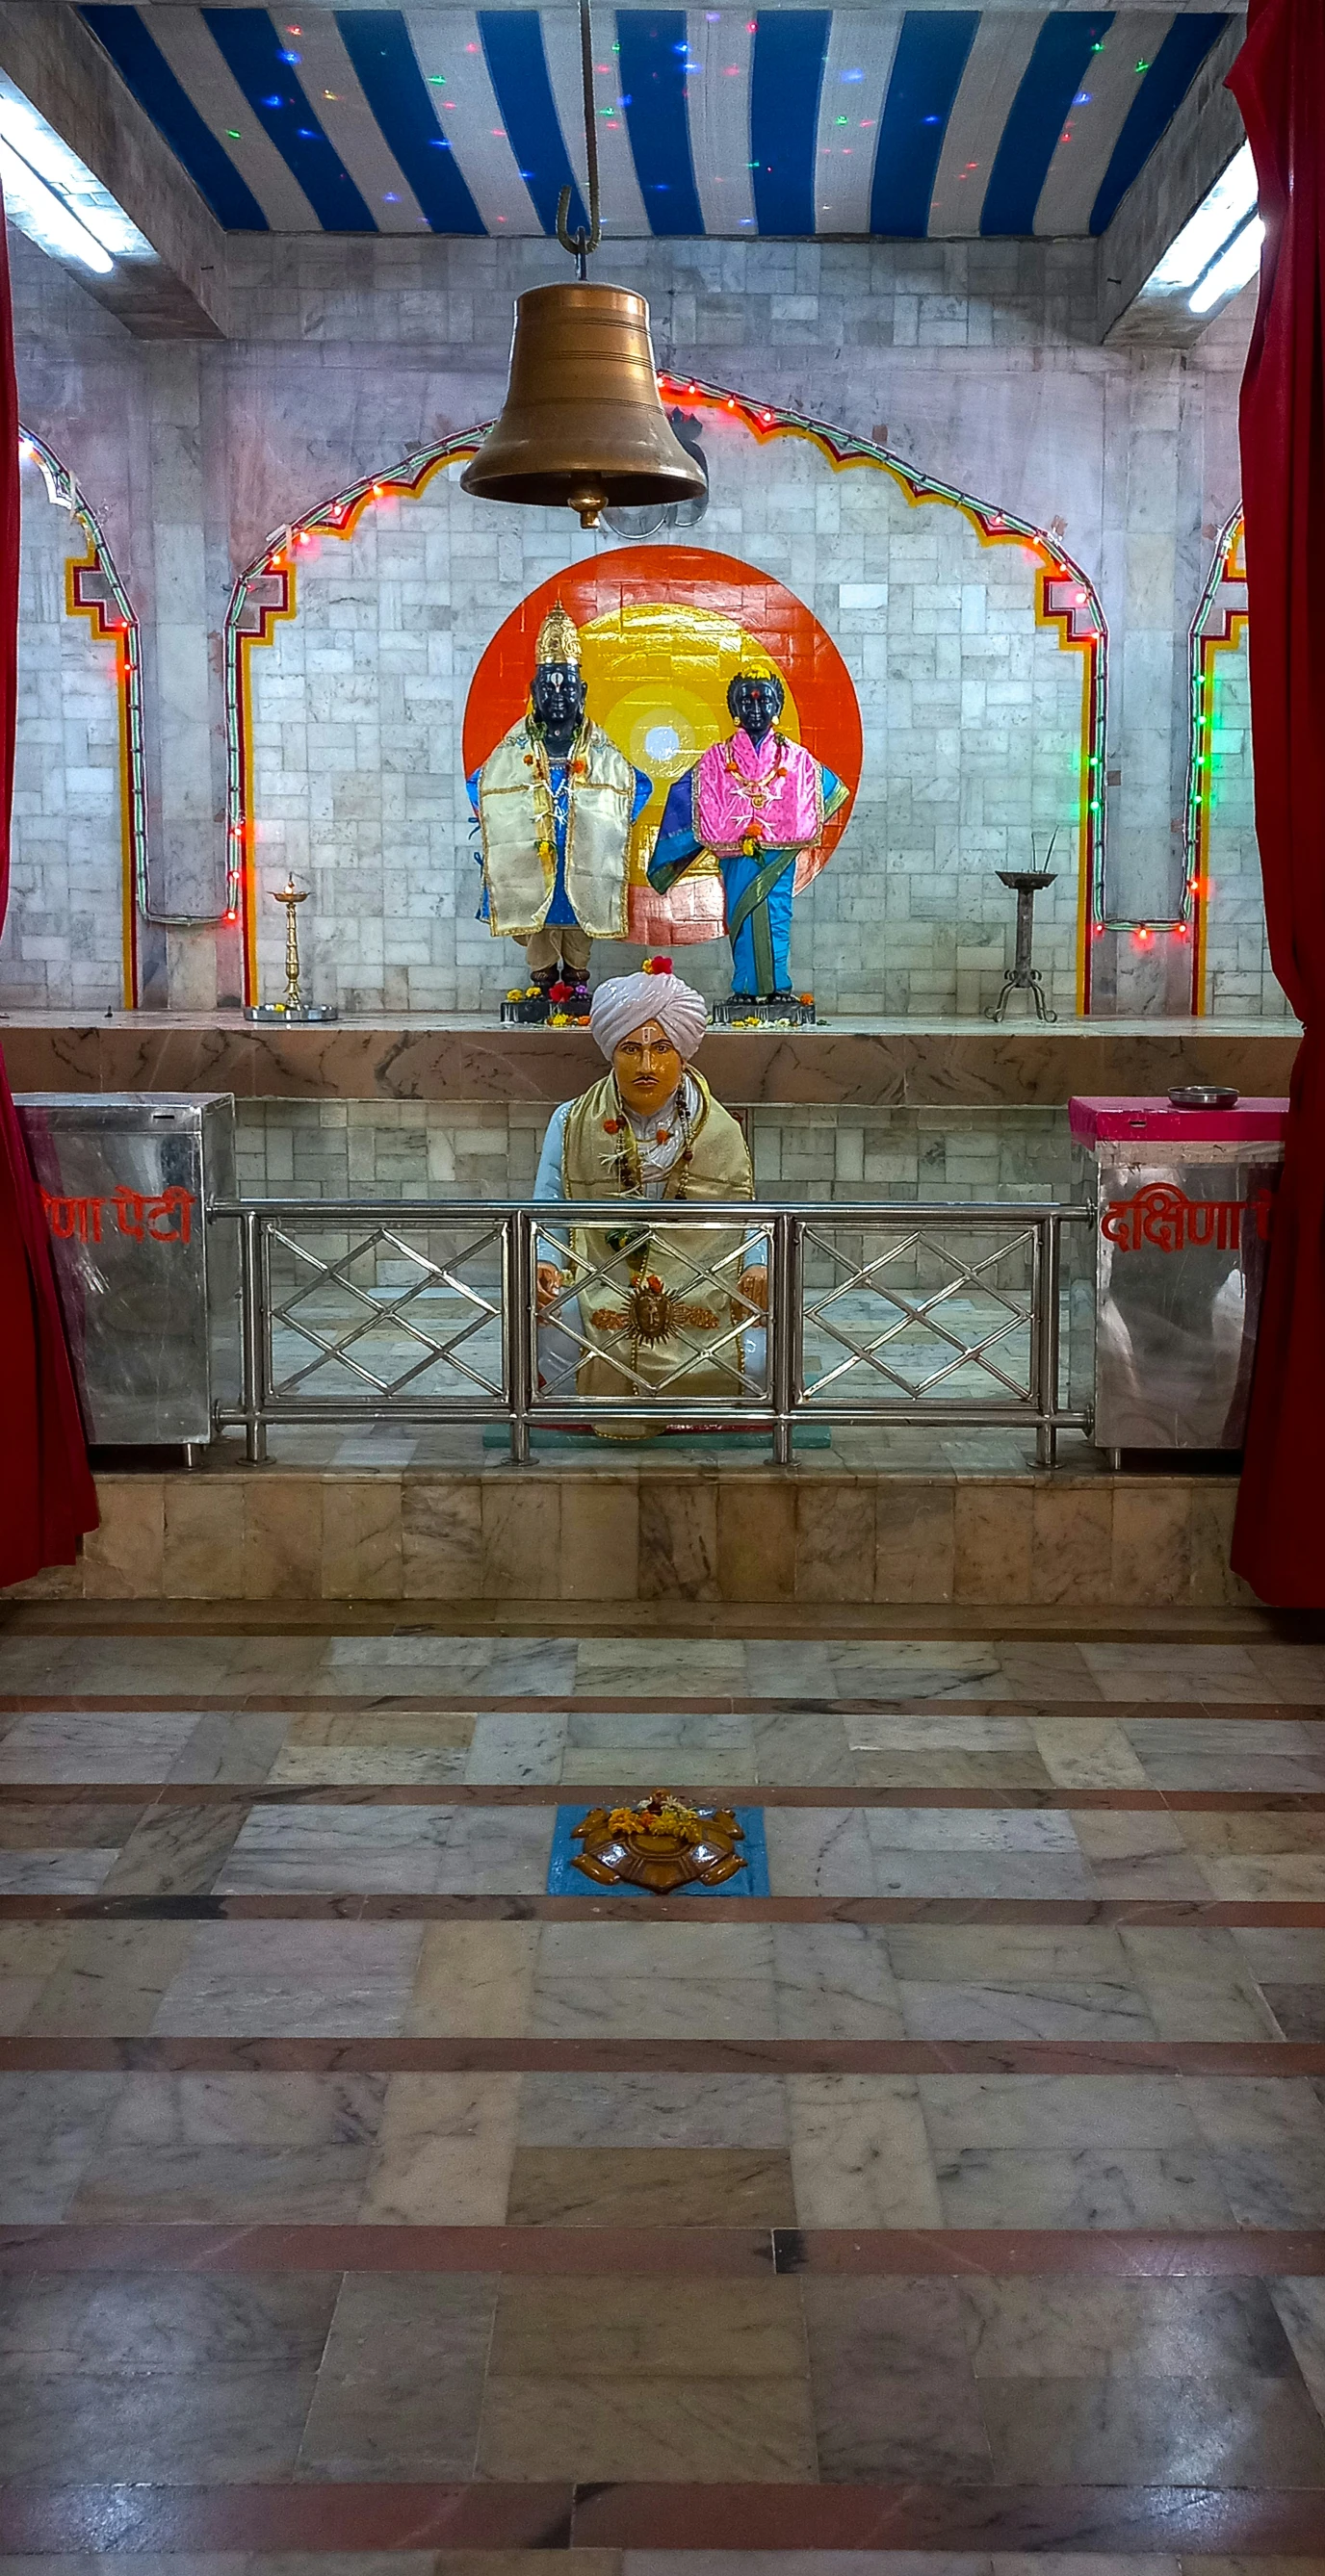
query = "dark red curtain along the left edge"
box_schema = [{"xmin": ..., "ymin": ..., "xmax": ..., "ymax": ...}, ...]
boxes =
[{"xmin": 0, "ymin": 198, "xmax": 98, "ymax": 1584}]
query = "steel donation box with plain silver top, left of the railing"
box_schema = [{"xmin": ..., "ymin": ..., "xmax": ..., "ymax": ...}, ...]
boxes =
[{"xmin": 15, "ymin": 1093, "xmax": 240, "ymax": 1443}]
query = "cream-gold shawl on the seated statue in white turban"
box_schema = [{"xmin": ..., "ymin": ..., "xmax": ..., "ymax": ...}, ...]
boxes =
[{"xmin": 533, "ymin": 1071, "xmax": 763, "ymax": 1404}]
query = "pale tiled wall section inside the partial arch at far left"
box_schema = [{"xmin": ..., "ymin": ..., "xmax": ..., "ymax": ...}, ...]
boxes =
[{"xmin": 0, "ymin": 456, "xmax": 123, "ymax": 1010}]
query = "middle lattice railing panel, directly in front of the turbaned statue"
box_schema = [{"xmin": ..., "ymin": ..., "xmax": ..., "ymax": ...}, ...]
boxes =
[{"xmin": 536, "ymin": 1211, "xmax": 768, "ymax": 1404}]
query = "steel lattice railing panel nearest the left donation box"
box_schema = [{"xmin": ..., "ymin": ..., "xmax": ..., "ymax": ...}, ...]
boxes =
[{"xmin": 266, "ymin": 1224, "xmax": 506, "ymax": 1406}]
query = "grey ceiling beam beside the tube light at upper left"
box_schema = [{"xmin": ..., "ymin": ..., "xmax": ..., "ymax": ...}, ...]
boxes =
[{"xmin": 0, "ymin": 0, "xmax": 229, "ymax": 340}]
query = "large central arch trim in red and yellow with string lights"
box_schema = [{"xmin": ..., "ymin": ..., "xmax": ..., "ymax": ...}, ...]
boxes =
[{"xmin": 224, "ymin": 374, "xmax": 1108, "ymax": 1013}]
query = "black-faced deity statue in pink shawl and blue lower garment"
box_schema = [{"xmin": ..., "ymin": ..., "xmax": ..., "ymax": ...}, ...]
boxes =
[{"xmin": 650, "ymin": 672, "xmax": 850, "ymax": 1002}]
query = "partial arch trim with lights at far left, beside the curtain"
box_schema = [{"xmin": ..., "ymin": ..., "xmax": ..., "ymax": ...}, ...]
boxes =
[{"xmin": 18, "ymin": 425, "xmax": 147, "ymax": 1010}]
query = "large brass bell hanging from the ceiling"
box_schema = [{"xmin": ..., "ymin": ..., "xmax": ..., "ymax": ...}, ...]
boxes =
[{"xmin": 461, "ymin": 278, "xmax": 704, "ymax": 528}]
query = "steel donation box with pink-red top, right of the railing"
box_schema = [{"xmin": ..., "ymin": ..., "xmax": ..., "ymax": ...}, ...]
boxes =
[{"xmin": 1070, "ymin": 1100, "xmax": 1289, "ymax": 1451}]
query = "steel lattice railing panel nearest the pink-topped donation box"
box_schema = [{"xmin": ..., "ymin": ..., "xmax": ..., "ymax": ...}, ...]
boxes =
[{"xmin": 802, "ymin": 1224, "xmax": 1033, "ymax": 1409}]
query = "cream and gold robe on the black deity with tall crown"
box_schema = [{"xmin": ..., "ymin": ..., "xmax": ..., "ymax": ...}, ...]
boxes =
[{"xmin": 467, "ymin": 716, "xmax": 652, "ymax": 940}]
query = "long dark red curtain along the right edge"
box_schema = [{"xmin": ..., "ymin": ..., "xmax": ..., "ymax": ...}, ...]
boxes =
[{"xmin": 1230, "ymin": 0, "xmax": 1325, "ymax": 1610}]
